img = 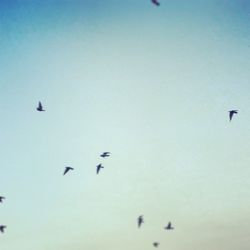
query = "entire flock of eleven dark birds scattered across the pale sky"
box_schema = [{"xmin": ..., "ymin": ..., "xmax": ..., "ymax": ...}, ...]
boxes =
[{"xmin": 0, "ymin": 0, "xmax": 238, "ymax": 247}]
